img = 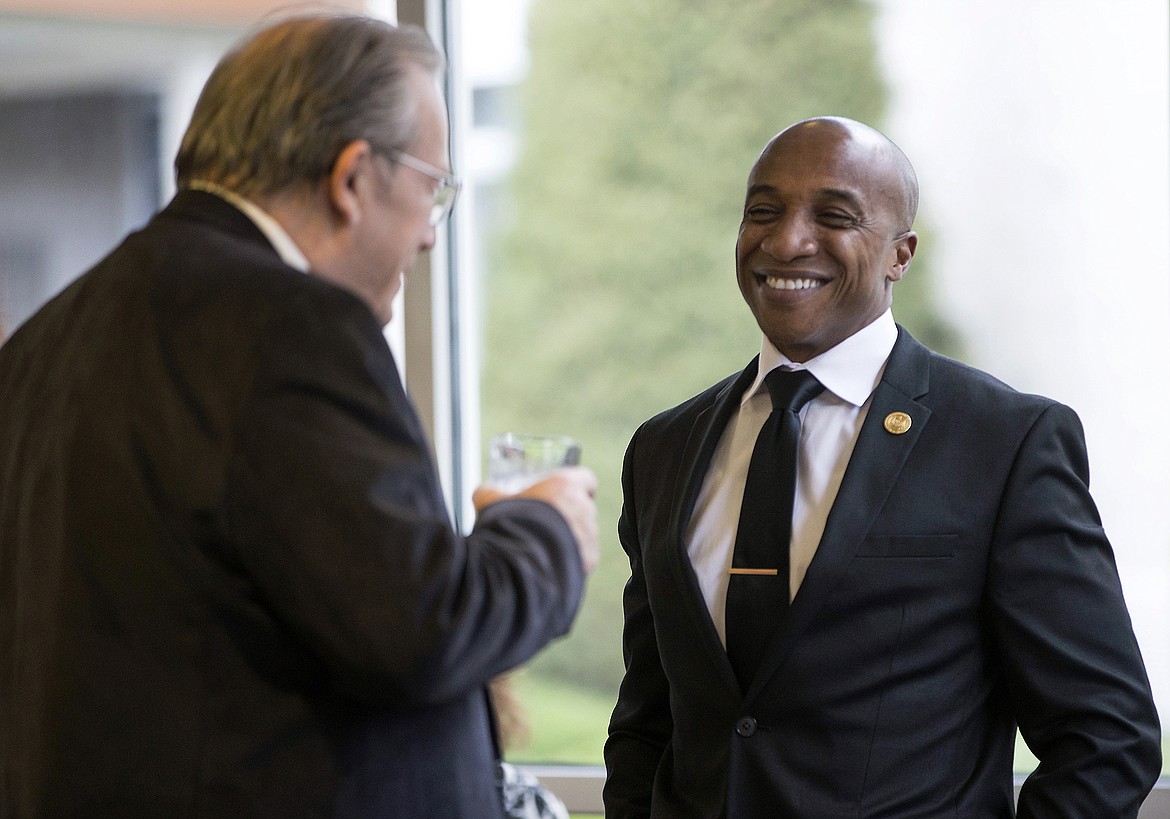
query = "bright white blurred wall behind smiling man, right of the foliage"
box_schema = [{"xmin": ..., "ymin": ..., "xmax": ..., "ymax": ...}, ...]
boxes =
[{"xmin": 878, "ymin": 0, "xmax": 1170, "ymax": 723}]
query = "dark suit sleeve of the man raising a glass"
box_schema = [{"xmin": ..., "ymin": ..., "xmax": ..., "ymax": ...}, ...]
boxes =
[{"xmin": 219, "ymin": 292, "xmax": 584, "ymax": 706}]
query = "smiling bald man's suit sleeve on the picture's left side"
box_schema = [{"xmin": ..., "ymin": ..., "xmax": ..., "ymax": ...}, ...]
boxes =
[{"xmin": 604, "ymin": 431, "xmax": 673, "ymax": 819}]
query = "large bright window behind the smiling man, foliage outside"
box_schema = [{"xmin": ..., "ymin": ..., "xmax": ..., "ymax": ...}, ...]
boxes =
[{"xmin": 439, "ymin": 0, "xmax": 1170, "ymax": 814}]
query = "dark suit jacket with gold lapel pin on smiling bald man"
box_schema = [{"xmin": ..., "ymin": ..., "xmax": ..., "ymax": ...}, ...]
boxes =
[{"xmin": 605, "ymin": 330, "xmax": 1161, "ymax": 819}]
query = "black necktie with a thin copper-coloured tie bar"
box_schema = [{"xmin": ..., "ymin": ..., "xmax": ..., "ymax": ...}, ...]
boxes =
[{"xmin": 725, "ymin": 369, "xmax": 825, "ymax": 691}]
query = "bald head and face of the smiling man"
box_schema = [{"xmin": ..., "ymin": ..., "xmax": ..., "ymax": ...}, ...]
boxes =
[{"xmin": 736, "ymin": 117, "xmax": 918, "ymax": 362}]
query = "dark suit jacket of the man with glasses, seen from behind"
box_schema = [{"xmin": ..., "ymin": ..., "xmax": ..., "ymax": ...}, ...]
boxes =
[{"xmin": 0, "ymin": 192, "xmax": 584, "ymax": 819}]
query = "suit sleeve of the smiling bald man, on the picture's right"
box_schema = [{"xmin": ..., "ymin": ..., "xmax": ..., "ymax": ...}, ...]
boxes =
[{"xmin": 989, "ymin": 405, "xmax": 1161, "ymax": 819}]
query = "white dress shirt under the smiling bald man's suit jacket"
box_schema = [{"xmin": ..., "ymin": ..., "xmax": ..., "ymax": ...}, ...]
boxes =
[{"xmin": 686, "ymin": 310, "xmax": 897, "ymax": 645}]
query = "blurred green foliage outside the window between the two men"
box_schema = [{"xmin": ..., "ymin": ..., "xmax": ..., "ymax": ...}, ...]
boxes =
[{"xmin": 483, "ymin": 0, "xmax": 959, "ymax": 702}]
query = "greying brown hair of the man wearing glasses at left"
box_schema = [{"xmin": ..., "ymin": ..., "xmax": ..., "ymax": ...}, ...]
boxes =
[{"xmin": 174, "ymin": 14, "xmax": 443, "ymax": 197}]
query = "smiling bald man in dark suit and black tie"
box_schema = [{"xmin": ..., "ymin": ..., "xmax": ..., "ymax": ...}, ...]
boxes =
[{"xmin": 605, "ymin": 117, "xmax": 1161, "ymax": 819}]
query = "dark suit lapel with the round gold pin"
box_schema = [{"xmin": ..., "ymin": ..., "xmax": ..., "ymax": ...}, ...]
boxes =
[{"xmin": 748, "ymin": 328, "xmax": 930, "ymax": 697}]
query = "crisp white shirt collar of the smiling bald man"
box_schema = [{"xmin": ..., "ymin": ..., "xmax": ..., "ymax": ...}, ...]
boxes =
[{"xmin": 741, "ymin": 310, "xmax": 897, "ymax": 407}]
